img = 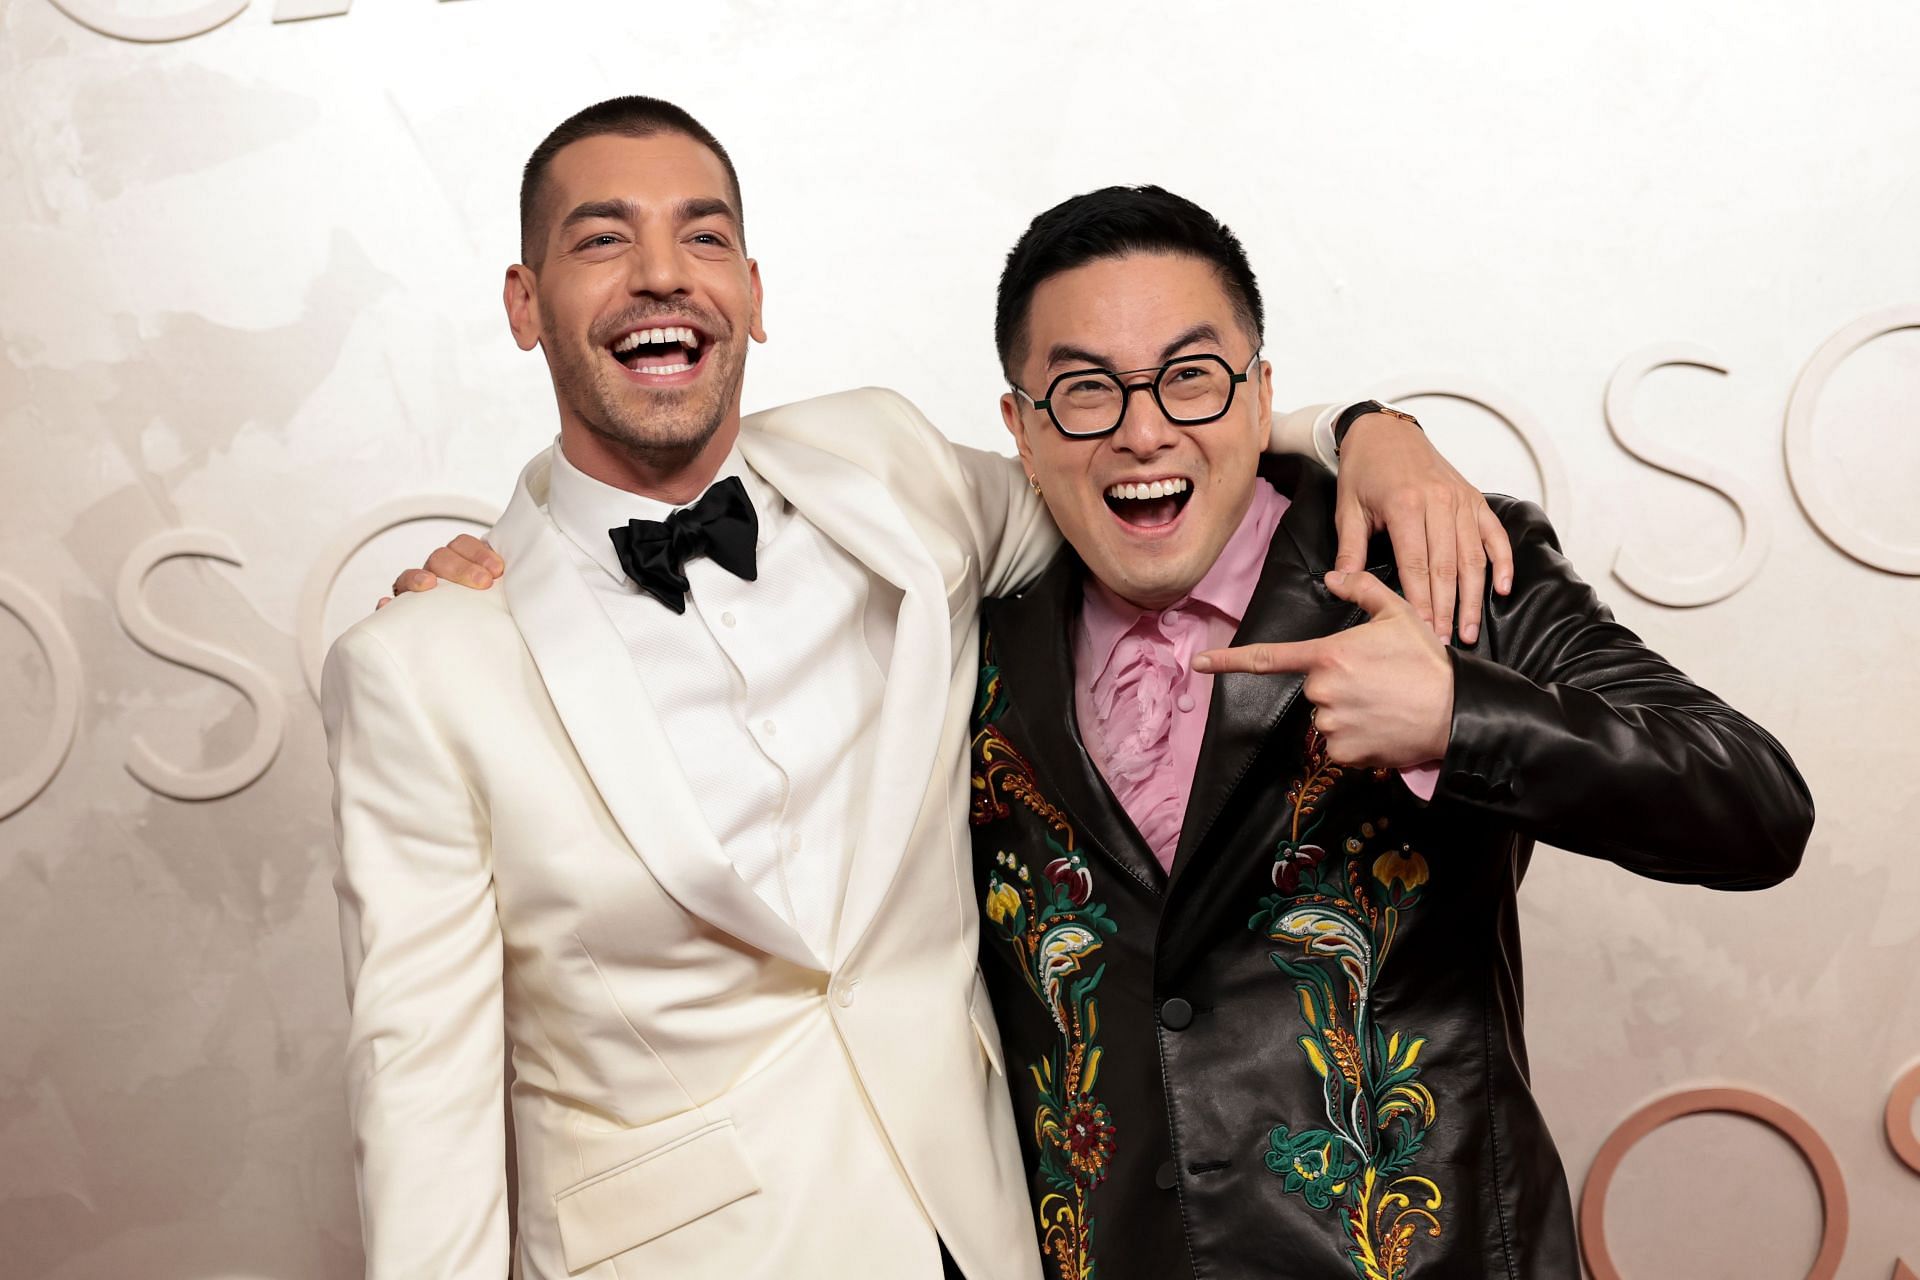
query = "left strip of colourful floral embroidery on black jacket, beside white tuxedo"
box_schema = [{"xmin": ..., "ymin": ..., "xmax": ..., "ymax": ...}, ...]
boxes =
[{"xmin": 972, "ymin": 644, "xmax": 1116, "ymax": 1280}]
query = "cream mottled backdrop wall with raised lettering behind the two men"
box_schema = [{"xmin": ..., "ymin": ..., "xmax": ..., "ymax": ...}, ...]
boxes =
[{"xmin": 0, "ymin": 0, "xmax": 1920, "ymax": 1280}]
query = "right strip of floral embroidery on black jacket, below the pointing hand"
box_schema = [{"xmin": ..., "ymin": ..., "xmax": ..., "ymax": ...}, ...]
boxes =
[{"xmin": 1248, "ymin": 729, "xmax": 1442, "ymax": 1280}]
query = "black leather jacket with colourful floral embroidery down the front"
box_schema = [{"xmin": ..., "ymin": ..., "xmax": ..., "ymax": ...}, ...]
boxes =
[{"xmin": 972, "ymin": 459, "xmax": 1812, "ymax": 1280}]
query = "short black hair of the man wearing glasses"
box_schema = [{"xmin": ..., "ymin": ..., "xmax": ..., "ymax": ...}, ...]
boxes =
[{"xmin": 993, "ymin": 186, "xmax": 1265, "ymax": 380}]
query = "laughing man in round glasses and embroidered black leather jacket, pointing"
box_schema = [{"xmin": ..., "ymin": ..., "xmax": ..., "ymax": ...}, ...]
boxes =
[{"xmin": 972, "ymin": 188, "xmax": 1812, "ymax": 1280}]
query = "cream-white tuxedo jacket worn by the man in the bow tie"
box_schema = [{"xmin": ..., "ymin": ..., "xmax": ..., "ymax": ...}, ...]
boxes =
[{"xmin": 323, "ymin": 390, "xmax": 1332, "ymax": 1280}]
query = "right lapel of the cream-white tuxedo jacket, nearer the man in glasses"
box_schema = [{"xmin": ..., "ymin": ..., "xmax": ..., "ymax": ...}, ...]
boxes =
[{"xmin": 739, "ymin": 428, "xmax": 952, "ymax": 965}]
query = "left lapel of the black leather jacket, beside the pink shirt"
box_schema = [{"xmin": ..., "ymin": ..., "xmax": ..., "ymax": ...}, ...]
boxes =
[{"xmin": 987, "ymin": 547, "xmax": 1165, "ymax": 894}]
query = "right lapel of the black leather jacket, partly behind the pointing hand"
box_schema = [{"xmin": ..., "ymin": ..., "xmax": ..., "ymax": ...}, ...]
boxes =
[{"xmin": 1171, "ymin": 457, "xmax": 1390, "ymax": 883}]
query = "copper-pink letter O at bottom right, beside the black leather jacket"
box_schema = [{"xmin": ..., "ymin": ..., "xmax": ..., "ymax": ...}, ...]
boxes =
[{"xmin": 1580, "ymin": 1088, "xmax": 1847, "ymax": 1280}]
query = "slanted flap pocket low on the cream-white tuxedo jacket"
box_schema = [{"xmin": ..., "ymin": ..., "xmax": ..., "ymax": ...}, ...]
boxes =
[{"xmin": 553, "ymin": 1121, "xmax": 760, "ymax": 1270}]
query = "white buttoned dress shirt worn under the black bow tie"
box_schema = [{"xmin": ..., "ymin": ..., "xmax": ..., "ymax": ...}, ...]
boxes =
[{"xmin": 549, "ymin": 447, "xmax": 891, "ymax": 965}]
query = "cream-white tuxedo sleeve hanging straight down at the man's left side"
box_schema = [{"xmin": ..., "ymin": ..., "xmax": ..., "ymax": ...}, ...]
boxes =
[{"xmin": 321, "ymin": 624, "xmax": 509, "ymax": 1278}]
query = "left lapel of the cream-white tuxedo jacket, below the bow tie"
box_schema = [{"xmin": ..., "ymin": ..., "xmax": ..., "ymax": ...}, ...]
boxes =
[{"xmin": 492, "ymin": 455, "xmax": 820, "ymax": 969}]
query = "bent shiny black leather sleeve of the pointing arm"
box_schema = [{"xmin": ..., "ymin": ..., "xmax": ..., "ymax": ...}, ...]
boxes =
[{"xmin": 1436, "ymin": 497, "xmax": 1812, "ymax": 889}]
